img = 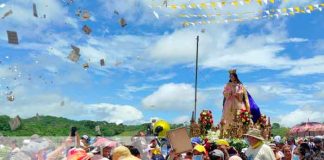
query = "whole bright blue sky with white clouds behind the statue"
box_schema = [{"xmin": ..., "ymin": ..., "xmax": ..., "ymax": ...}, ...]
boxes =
[{"xmin": 0, "ymin": 0, "xmax": 324, "ymax": 126}]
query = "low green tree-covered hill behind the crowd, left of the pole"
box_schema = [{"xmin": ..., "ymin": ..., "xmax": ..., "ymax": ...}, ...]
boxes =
[{"xmin": 0, "ymin": 116, "xmax": 147, "ymax": 136}]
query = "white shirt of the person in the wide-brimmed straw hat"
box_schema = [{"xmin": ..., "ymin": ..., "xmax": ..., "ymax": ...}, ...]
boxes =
[{"xmin": 245, "ymin": 144, "xmax": 276, "ymax": 160}]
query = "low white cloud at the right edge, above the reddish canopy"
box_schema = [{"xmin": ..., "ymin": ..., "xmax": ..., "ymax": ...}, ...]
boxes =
[{"xmin": 278, "ymin": 106, "xmax": 324, "ymax": 127}]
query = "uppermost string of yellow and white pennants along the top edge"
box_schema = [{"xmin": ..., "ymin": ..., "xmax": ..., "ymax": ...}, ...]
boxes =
[{"xmin": 149, "ymin": 0, "xmax": 289, "ymax": 10}]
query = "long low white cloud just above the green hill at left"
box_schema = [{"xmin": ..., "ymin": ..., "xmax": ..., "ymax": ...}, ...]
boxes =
[{"xmin": 0, "ymin": 87, "xmax": 143, "ymax": 123}]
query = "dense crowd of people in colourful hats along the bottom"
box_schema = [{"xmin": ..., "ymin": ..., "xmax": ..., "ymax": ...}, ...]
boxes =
[{"xmin": 0, "ymin": 129, "xmax": 324, "ymax": 160}]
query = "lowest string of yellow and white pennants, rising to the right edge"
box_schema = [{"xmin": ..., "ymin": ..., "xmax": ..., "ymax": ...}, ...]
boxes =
[{"xmin": 183, "ymin": 3, "xmax": 324, "ymax": 27}]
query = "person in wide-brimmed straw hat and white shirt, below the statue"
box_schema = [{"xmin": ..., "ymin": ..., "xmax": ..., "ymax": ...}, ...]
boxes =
[{"xmin": 244, "ymin": 129, "xmax": 276, "ymax": 160}]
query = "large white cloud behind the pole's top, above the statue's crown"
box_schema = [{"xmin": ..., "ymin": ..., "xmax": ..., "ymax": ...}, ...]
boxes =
[{"xmin": 149, "ymin": 22, "xmax": 291, "ymax": 69}]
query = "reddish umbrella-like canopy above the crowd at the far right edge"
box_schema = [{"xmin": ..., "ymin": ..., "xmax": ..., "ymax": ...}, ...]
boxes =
[{"xmin": 289, "ymin": 122, "xmax": 324, "ymax": 137}]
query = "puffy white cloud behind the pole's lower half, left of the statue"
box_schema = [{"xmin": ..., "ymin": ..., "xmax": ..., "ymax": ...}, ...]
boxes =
[{"xmin": 142, "ymin": 83, "xmax": 205, "ymax": 109}]
